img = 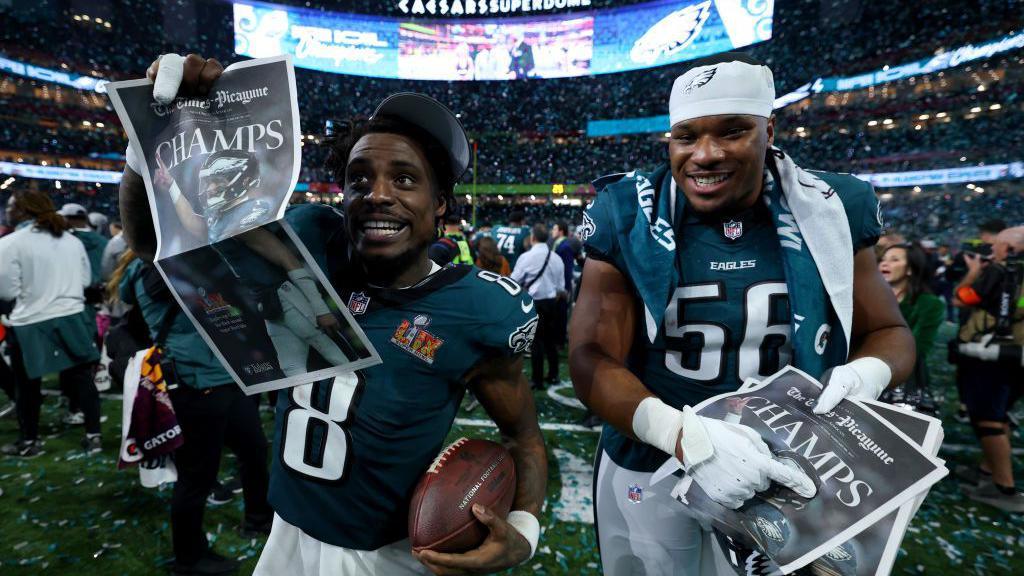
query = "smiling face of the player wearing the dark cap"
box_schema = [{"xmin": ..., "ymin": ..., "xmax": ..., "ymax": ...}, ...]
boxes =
[{"xmin": 344, "ymin": 132, "xmax": 445, "ymax": 276}]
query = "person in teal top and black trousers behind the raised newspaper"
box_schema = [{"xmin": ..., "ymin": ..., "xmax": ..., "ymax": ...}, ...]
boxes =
[{"xmin": 116, "ymin": 252, "xmax": 273, "ymax": 575}]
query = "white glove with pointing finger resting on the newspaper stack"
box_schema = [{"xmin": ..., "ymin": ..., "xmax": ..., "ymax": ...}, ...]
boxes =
[{"xmin": 682, "ymin": 406, "xmax": 817, "ymax": 509}]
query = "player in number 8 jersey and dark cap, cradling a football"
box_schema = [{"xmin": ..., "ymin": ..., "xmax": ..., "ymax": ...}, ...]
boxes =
[{"xmin": 120, "ymin": 54, "xmax": 547, "ymax": 576}]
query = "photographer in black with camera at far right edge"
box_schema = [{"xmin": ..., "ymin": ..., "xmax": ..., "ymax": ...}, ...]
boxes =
[{"xmin": 951, "ymin": 227, "xmax": 1024, "ymax": 512}]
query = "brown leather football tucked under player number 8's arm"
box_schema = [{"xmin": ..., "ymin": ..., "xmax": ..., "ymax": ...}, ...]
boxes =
[{"xmin": 409, "ymin": 438, "xmax": 516, "ymax": 552}]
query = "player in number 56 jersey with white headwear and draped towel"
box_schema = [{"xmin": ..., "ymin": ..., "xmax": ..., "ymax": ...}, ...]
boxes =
[{"xmin": 569, "ymin": 53, "xmax": 914, "ymax": 575}]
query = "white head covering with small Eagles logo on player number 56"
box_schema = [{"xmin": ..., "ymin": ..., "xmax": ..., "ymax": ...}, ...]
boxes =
[{"xmin": 669, "ymin": 61, "xmax": 775, "ymax": 126}]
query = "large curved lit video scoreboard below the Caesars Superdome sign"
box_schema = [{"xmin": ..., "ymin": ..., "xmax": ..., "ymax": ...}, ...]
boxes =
[{"xmin": 233, "ymin": 0, "xmax": 774, "ymax": 80}]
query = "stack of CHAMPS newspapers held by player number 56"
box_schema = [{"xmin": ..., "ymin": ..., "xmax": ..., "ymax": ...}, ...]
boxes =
[{"xmin": 651, "ymin": 367, "xmax": 948, "ymax": 575}]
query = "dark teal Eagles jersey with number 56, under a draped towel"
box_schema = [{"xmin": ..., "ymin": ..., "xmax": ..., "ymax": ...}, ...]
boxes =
[{"xmin": 584, "ymin": 166, "xmax": 881, "ymax": 471}]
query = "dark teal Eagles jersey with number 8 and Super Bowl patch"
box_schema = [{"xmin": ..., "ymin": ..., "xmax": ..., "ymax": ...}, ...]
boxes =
[{"xmin": 269, "ymin": 205, "xmax": 537, "ymax": 550}]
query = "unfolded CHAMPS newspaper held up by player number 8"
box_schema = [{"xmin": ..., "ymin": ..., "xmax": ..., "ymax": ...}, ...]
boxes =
[{"xmin": 108, "ymin": 56, "xmax": 380, "ymax": 394}]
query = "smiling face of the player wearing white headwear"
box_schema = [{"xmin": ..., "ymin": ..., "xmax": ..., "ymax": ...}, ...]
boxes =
[{"xmin": 669, "ymin": 115, "xmax": 775, "ymax": 215}]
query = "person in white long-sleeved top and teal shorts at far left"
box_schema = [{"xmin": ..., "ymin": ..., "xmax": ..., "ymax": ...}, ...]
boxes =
[{"xmin": 0, "ymin": 191, "xmax": 102, "ymax": 457}]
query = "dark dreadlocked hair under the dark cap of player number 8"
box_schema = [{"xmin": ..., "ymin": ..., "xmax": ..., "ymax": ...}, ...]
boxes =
[{"xmin": 325, "ymin": 115, "xmax": 456, "ymax": 230}]
